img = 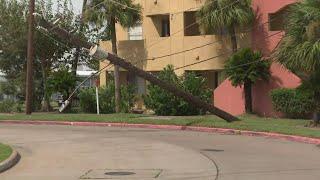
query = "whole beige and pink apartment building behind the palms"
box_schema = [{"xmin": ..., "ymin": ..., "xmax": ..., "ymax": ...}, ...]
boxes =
[{"xmin": 100, "ymin": 0, "xmax": 300, "ymax": 115}]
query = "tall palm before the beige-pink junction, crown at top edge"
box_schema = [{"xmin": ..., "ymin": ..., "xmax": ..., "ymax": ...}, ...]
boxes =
[{"xmin": 197, "ymin": 0, "xmax": 255, "ymax": 52}]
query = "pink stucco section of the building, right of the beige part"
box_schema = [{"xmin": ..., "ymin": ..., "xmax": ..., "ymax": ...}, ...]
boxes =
[{"xmin": 214, "ymin": 0, "xmax": 300, "ymax": 117}]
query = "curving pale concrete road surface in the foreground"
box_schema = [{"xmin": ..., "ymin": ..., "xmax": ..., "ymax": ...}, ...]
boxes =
[{"xmin": 0, "ymin": 124, "xmax": 320, "ymax": 180}]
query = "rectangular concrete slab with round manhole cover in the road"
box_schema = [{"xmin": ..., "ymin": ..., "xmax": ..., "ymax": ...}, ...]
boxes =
[{"xmin": 80, "ymin": 169, "xmax": 162, "ymax": 180}]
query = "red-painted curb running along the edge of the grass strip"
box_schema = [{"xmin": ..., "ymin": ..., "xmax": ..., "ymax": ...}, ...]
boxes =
[{"xmin": 0, "ymin": 120, "xmax": 320, "ymax": 145}]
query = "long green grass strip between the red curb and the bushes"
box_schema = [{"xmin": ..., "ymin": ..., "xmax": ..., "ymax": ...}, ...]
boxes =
[{"xmin": 0, "ymin": 113, "xmax": 320, "ymax": 138}]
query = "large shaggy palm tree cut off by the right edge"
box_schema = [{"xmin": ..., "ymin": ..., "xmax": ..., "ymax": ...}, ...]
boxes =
[{"xmin": 273, "ymin": 0, "xmax": 320, "ymax": 125}]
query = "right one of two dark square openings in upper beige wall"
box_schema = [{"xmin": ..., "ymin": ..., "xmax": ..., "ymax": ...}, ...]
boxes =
[{"xmin": 184, "ymin": 11, "xmax": 201, "ymax": 36}]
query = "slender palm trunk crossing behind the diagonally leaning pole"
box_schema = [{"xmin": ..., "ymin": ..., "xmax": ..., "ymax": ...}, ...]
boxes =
[{"xmin": 110, "ymin": 17, "xmax": 121, "ymax": 113}]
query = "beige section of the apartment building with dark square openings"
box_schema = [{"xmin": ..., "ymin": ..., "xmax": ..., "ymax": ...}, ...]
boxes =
[{"xmin": 100, "ymin": 0, "xmax": 250, "ymax": 93}]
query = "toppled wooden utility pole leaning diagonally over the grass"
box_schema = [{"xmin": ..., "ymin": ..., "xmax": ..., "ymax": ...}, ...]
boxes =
[{"xmin": 40, "ymin": 20, "xmax": 239, "ymax": 122}]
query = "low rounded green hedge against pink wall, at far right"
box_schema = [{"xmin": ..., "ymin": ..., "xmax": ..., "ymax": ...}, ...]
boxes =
[{"xmin": 270, "ymin": 88, "xmax": 315, "ymax": 118}]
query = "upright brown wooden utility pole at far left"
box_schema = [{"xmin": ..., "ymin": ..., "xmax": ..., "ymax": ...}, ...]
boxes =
[{"xmin": 26, "ymin": 0, "xmax": 35, "ymax": 115}]
